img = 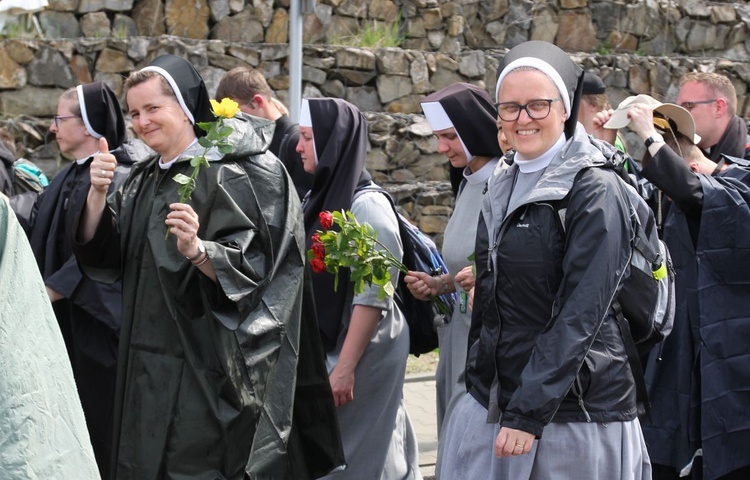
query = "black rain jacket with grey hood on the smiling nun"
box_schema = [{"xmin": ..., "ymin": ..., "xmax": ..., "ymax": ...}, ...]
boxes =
[{"xmin": 466, "ymin": 127, "xmax": 637, "ymax": 436}]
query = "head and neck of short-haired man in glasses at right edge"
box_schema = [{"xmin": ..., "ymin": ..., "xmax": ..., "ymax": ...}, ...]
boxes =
[{"xmin": 677, "ymin": 73, "xmax": 750, "ymax": 163}]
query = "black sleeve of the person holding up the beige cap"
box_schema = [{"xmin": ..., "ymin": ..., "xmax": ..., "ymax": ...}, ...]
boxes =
[{"xmin": 641, "ymin": 145, "xmax": 703, "ymax": 216}]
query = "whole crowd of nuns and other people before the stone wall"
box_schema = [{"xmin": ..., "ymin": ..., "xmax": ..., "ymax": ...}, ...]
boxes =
[{"xmin": 0, "ymin": 41, "xmax": 750, "ymax": 480}]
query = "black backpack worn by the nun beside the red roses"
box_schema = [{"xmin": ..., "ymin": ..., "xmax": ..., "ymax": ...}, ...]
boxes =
[{"xmin": 354, "ymin": 184, "xmax": 455, "ymax": 356}]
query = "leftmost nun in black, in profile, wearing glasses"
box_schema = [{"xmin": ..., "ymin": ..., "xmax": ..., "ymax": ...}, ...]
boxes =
[{"xmin": 30, "ymin": 81, "xmax": 134, "ymax": 473}]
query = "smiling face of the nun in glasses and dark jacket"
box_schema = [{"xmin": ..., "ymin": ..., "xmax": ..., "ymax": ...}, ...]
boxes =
[{"xmin": 497, "ymin": 70, "xmax": 565, "ymax": 159}]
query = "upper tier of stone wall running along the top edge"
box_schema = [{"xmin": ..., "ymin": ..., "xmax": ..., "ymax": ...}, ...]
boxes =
[{"xmin": 13, "ymin": 0, "xmax": 750, "ymax": 60}]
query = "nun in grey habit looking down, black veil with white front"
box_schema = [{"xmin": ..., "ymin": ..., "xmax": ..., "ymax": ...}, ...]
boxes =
[{"xmin": 404, "ymin": 83, "xmax": 505, "ymax": 439}]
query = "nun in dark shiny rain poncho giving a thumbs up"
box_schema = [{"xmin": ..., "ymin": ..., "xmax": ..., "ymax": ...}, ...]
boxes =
[{"xmin": 75, "ymin": 55, "xmax": 343, "ymax": 480}]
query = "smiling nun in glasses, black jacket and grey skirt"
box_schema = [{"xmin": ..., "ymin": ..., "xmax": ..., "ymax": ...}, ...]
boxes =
[{"xmin": 438, "ymin": 41, "xmax": 651, "ymax": 480}]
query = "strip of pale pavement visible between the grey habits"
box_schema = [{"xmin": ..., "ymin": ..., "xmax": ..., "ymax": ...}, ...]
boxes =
[{"xmin": 404, "ymin": 372, "xmax": 437, "ymax": 480}]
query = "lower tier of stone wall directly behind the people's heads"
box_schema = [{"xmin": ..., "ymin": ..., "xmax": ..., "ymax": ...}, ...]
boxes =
[{"xmin": 0, "ymin": 36, "xmax": 750, "ymax": 246}]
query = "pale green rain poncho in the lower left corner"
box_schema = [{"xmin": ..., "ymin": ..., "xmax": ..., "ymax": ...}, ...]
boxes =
[{"xmin": 0, "ymin": 194, "xmax": 99, "ymax": 480}]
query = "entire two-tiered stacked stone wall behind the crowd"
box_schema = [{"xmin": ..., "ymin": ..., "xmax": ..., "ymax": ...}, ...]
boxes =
[{"xmin": 0, "ymin": 0, "xmax": 750, "ymax": 241}]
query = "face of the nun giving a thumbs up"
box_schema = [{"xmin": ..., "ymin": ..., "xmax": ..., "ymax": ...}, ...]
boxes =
[{"xmin": 128, "ymin": 77, "xmax": 195, "ymax": 161}]
